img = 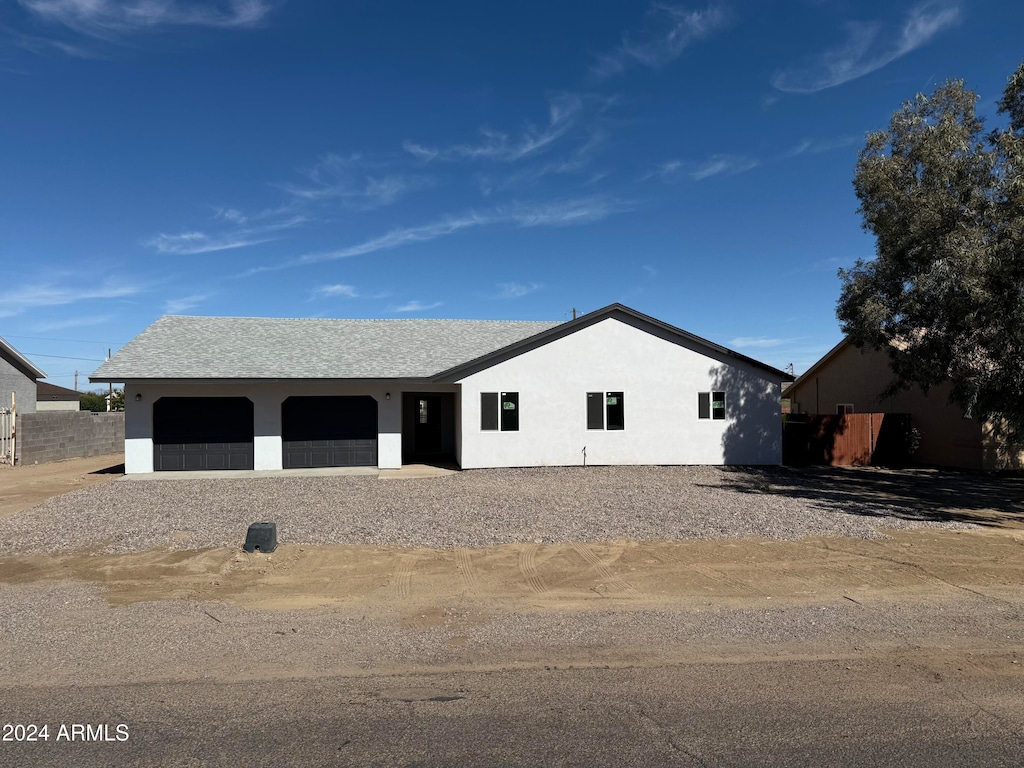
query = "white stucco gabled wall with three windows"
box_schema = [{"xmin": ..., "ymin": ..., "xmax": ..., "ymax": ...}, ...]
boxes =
[{"xmin": 459, "ymin": 317, "xmax": 782, "ymax": 469}]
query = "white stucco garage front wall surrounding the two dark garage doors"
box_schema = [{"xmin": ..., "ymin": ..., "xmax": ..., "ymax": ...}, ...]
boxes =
[{"xmin": 125, "ymin": 379, "xmax": 436, "ymax": 474}]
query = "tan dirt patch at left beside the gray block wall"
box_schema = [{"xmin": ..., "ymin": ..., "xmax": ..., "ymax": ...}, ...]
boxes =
[{"xmin": 0, "ymin": 454, "xmax": 125, "ymax": 518}]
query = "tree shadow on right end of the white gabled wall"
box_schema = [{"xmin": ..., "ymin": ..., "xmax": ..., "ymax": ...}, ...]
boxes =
[{"xmin": 709, "ymin": 366, "xmax": 782, "ymax": 464}]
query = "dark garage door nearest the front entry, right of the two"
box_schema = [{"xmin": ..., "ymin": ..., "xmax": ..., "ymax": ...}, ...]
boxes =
[{"xmin": 281, "ymin": 395, "xmax": 377, "ymax": 469}]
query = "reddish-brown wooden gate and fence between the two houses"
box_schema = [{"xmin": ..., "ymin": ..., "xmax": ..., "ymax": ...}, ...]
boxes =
[{"xmin": 782, "ymin": 414, "xmax": 910, "ymax": 467}]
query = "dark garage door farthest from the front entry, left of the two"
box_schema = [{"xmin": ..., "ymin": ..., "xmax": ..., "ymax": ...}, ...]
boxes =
[{"xmin": 153, "ymin": 397, "xmax": 253, "ymax": 472}]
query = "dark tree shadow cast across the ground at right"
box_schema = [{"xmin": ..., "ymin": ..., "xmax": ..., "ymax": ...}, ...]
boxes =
[{"xmin": 708, "ymin": 467, "xmax": 1024, "ymax": 528}]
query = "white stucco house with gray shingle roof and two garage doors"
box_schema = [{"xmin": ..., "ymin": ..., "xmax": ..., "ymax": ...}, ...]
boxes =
[{"xmin": 90, "ymin": 304, "xmax": 787, "ymax": 473}]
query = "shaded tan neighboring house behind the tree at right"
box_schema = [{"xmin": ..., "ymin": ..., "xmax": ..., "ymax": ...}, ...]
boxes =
[{"xmin": 782, "ymin": 340, "xmax": 1024, "ymax": 470}]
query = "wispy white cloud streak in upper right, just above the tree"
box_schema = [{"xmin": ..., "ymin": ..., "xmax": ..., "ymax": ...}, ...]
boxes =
[{"xmin": 771, "ymin": 0, "xmax": 959, "ymax": 93}]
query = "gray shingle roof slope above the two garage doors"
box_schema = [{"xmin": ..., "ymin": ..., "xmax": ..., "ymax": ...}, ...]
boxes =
[{"xmin": 89, "ymin": 315, "xmax": 560, "ymax": 381}]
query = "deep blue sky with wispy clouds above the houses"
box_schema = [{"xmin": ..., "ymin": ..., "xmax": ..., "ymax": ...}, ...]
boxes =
[{"xmin": 0, "ymin": 0, "xmax": 1024, "ymax": 388}]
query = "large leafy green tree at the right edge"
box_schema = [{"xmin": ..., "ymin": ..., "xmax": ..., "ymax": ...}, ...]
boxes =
[{"xmin": 837, "ymin": 62, "xmax": 1024, "ymax": 438}]
